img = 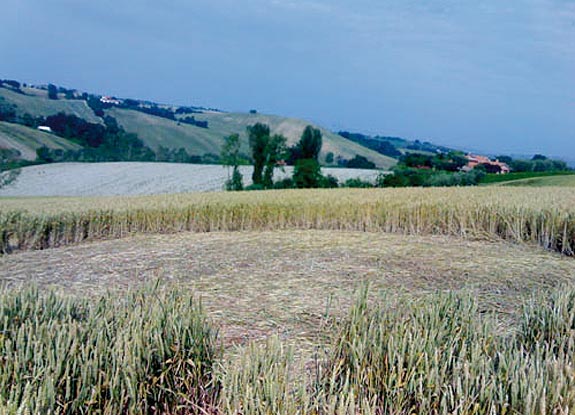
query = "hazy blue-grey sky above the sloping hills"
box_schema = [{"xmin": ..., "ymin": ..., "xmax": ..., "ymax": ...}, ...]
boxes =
[{"xmin": 0, "ymin": 0, "xmax": 575, "ymax": 160}]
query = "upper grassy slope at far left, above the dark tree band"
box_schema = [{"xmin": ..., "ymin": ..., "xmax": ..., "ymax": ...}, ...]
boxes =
[{"xmin": 0, "ymin": 88, "xmax": 102, "ymax": 123}]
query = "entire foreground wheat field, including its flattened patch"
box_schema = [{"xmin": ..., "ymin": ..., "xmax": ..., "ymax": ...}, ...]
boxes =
[{"xmin": 0, "ymin": 187, "xmax": 575, "ymax": 415}]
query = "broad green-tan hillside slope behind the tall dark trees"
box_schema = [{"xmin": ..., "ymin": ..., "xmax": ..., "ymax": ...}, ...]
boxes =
[{"xmin": 109, "ymin": 109, "xmax": 395, "ymax": 168}]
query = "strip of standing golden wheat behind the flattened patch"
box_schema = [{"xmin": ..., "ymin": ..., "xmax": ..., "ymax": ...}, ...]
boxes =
[{"xmin": 0, "ymin": 187, "xmax": 575, "ymax": 255}]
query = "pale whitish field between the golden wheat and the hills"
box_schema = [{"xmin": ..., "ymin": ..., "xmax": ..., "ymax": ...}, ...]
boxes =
[{"xmin": 0, "ymin": 162, "xmax": 379, "ymax": 196}]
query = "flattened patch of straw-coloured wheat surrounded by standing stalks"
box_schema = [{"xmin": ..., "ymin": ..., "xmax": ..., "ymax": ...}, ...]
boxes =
[{"xmin": 0, "ymin": 230, "xmax": 575, "ymax": 354}]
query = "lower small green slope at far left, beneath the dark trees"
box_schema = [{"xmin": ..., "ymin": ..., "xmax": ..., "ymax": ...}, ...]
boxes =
[{"xmin": 0, "ymin": 122, "xmax": 80, "ymax": 160}]
